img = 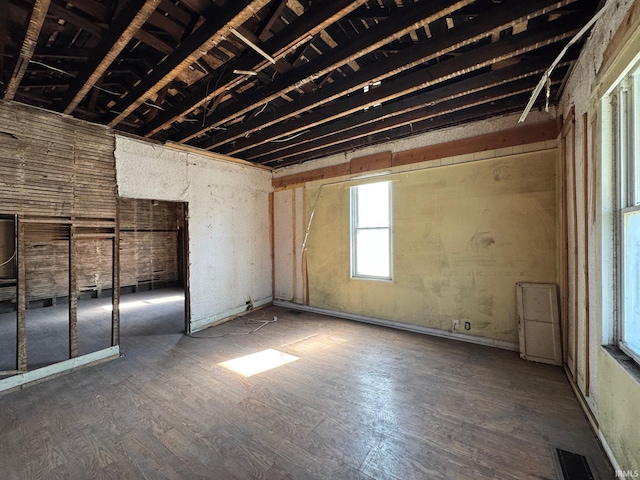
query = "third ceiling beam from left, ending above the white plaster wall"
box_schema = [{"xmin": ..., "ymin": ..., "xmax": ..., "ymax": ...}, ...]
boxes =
[{"xmin": 107, "ymin": 0, "xmax": 269, "ymax": 127}]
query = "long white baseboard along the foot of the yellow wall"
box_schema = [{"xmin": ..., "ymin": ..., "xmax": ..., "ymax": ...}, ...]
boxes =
[{"xmin": 273, "ymin": 300, "xmax": 520, "ymax": 352}]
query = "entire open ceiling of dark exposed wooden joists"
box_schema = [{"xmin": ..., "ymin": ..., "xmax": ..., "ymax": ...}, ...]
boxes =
[{"xmin": 0, "ymin": 0, "xmax": 603, "ymax": 166}]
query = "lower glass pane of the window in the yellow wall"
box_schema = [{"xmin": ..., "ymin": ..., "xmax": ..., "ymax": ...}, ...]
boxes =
[{"xmin": 354, "ymin": 228, "xmax": 391, "ymax": 278}]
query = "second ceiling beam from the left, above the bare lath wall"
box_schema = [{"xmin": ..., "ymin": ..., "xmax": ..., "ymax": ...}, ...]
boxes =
[{"xmin": 61, "ymin": 0, "xmax": 162, "ymax": 114}]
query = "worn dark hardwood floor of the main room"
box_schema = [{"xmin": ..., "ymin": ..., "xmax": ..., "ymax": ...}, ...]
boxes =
[{"xmin": 0, "ymin": 307, "xmax": 613, "ymax": 480}]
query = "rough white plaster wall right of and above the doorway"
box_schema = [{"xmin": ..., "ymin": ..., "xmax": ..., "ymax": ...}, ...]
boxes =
[{"xmin": 115, "ymin": 135, "xmax": 272, "ymax": 331}]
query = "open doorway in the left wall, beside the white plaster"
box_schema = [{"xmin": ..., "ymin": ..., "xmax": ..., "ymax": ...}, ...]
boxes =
[{"xmin": 118, "ymin": 198, "xmax": 189, "ymax": 351}]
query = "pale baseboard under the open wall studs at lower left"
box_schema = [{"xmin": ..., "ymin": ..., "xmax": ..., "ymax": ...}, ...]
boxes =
[{"xmin": 0, "ymin": 345, "xmax": 120, "ymax": 393}]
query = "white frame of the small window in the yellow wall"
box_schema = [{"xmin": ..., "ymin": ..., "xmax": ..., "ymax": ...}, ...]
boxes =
[{"xmin": 349, "ymin": 180, "xmax": 394, "ymax": 282}]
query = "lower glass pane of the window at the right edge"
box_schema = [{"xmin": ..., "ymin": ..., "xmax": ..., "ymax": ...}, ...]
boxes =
[{"xmin": 623, "ymin": 211, "xmax": 640, "ymax": 355}]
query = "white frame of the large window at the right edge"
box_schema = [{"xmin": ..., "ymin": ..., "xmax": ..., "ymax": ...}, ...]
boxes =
[{"xmin": 610, "ymin": 59, "xmax": 640, "ymax": 364}]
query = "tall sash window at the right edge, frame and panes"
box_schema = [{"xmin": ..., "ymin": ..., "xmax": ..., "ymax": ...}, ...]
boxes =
[{"xmin": 614, "ymin": 58, "xmax": 640, "ymax": 361}]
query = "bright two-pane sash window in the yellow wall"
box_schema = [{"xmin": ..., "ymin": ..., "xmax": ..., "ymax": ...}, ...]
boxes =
[{"xmin": 351, "ymin": 182, "xmax": 392, "ymax": 280}]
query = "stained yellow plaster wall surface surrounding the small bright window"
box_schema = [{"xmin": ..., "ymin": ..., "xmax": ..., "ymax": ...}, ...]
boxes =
[{"xmin": 305, "ymin": 149, "xmax": 558, "ymax": 345}]
